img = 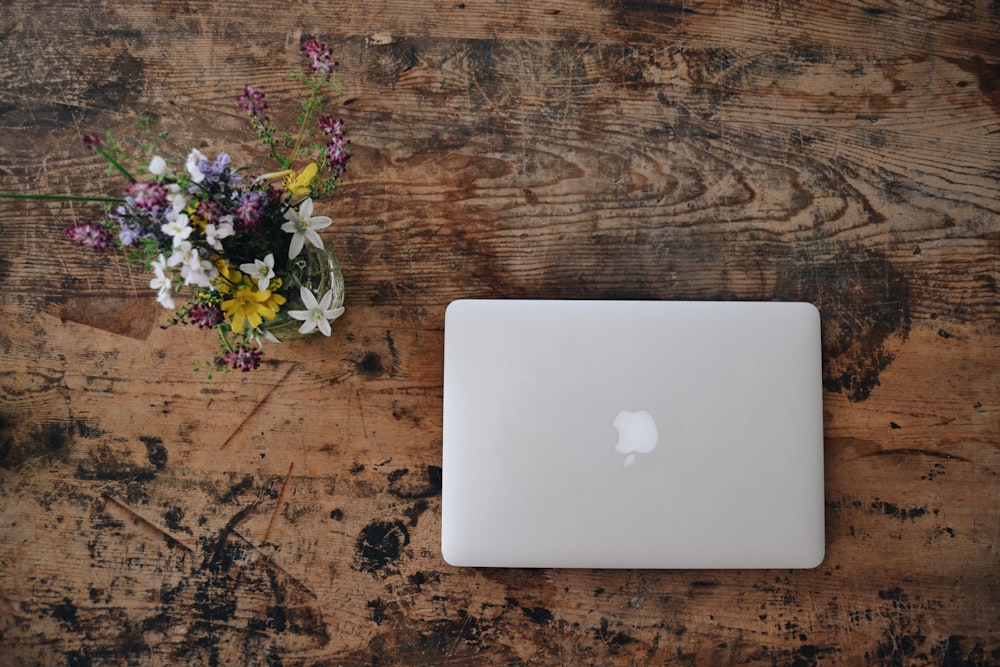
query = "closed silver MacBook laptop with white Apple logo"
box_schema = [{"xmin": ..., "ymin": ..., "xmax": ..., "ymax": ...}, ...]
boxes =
[{"xmin": 441, "ymin": 300, "xmax": 825, "ymax": 568}]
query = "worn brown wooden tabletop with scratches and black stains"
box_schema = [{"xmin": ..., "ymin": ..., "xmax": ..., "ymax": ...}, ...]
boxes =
[{"xmin": 0, "ymin": 0, "xmax": 1000, "ymax": 665}]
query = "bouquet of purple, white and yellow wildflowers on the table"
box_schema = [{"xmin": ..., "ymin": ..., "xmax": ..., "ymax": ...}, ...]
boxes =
[{"xmin": 13, "ymin": 39, "xmax": 350, "ymax": 371}]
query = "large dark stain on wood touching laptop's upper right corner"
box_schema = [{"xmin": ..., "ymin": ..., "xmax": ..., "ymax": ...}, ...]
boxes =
[{"xmin": 775, "ymin": 248, "xmax": 910, "ymax": 402}]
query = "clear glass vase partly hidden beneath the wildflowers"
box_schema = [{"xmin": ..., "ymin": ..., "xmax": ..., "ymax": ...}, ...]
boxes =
[{"xmin": 261, "ymin": 243, "xmax": 344, "ymax": 341}]
